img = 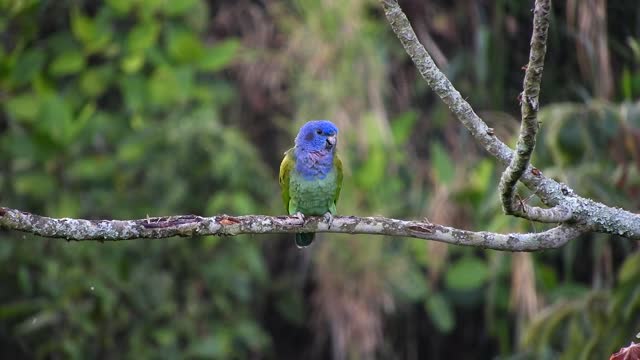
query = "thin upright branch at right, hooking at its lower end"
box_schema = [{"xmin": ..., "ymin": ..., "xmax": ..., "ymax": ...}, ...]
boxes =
[{"xmin": 498, "ymin": 0, "xmax": 551, "ymax": 218}]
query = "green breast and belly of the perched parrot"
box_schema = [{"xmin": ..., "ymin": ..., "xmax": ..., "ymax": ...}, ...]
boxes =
[{"xmin": 289, "ymin": 169, "xmax": 338, "ymax": 215}]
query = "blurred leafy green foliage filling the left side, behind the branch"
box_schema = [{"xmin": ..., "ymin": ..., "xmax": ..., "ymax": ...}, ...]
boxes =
[{"xmin": 0, "ymin": 0, "xmax": 275, "ymax": 359}]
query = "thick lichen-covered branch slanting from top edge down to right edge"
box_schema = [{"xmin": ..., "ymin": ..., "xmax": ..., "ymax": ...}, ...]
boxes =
[{"xmin": 380, "ymin": 0, "xmax": 640, "ymax": 239}]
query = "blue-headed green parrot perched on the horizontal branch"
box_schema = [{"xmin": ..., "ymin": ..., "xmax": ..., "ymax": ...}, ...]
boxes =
[{"xmin": 279, "ymin": 120, "xmax": 343, "ymax": 248}]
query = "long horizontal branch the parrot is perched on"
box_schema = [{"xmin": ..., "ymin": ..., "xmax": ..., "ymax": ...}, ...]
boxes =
[{"xmin": 0, "ymin": 208, "xmax": 587, "ymax": 251}]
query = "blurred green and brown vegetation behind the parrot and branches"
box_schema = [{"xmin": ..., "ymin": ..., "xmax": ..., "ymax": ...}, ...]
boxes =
[{"xmin": 0, "ymin": 0, "xmax": 640, "ymax": 359}]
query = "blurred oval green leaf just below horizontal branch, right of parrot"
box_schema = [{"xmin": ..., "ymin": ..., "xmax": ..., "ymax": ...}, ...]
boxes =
[{"xmin": 445, "ymin": 257, "xmax": 489, "ymax": 291}]
